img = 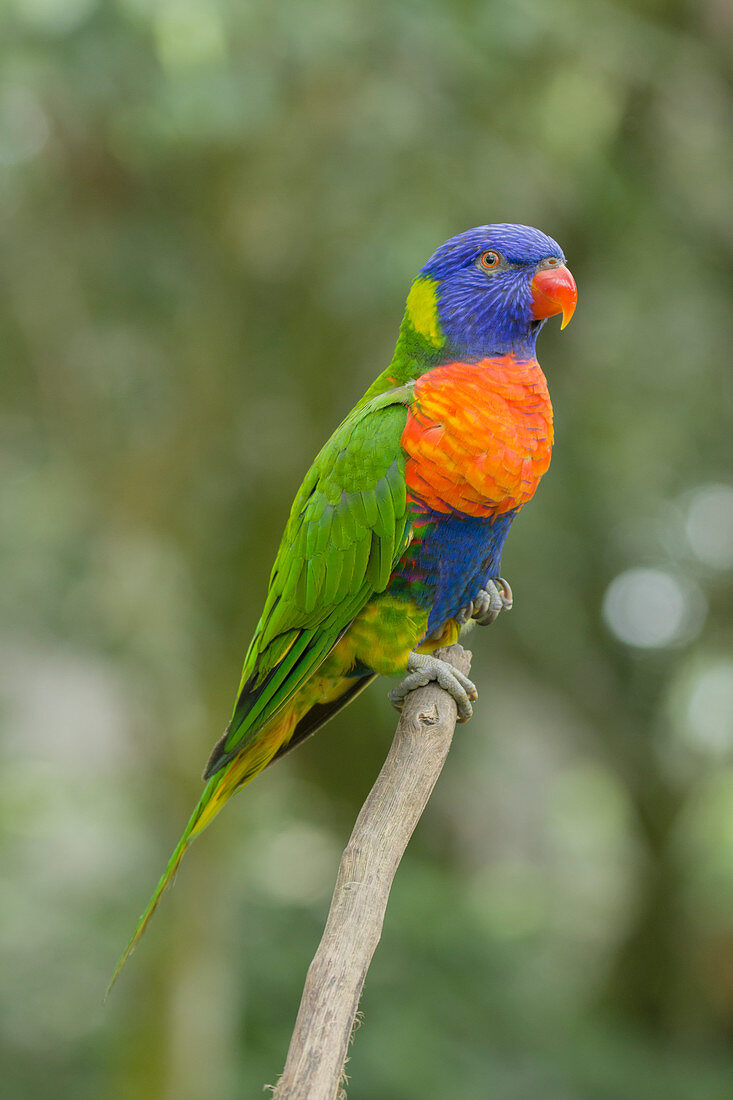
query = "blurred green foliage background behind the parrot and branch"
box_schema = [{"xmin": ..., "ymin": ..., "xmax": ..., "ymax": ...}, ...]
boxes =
[{"xmin": 0, "ymin": 0, "xmax": 733, "ymax": 1100}]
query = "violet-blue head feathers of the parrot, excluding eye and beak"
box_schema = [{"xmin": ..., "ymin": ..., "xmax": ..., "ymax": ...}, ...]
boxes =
[{"xmin": 420, "ymin": 223, "xmax": 565, "ymax": 359}]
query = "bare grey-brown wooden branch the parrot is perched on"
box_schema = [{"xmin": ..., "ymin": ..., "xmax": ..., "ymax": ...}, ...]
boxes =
[{"xmin": 274, "ymin": 646, "xmax": 471, "ymax": 1100}]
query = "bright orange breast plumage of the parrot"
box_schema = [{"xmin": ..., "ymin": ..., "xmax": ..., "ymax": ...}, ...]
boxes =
[{"xmin": 402, "ymin": 355, "xmax": 553, "ymax": 516}]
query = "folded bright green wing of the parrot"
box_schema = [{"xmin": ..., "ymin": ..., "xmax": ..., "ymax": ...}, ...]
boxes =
[{"xmin": 204, "ymin": 385, "xmax": 413, "ymax": 779}]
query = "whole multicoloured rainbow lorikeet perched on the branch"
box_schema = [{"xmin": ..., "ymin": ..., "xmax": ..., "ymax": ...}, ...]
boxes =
[{"xmin": 110, "ymin": 224, "xmax": 577, "ymax": 990}]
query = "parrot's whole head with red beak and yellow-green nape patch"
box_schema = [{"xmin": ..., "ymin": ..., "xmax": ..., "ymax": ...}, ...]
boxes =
[{"xmin": 407, "ymin": 224, "xmax": 578, "ymax": 359}]
